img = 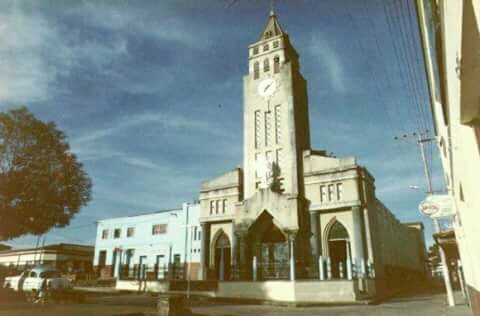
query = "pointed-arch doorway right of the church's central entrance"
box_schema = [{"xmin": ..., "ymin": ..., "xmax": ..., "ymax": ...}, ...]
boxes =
[{"xmin": 328, "ymin": 221, "xmax": 350, "ymax": 278}]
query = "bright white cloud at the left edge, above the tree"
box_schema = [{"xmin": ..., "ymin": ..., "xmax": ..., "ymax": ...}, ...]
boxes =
[{"xmin": 0, "ymin": 2, "xmax": 126, "ymax": 105}]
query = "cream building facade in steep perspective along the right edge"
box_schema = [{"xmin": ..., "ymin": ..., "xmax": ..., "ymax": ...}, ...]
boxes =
[{"xmin": 417, "ymin": 0, "xmax": 480, "ymax": 315}]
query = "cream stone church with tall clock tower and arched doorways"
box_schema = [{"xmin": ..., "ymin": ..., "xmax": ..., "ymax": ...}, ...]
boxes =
[{"xmin": 200, "ymin": 13, "xmax": 425, "ymax": 298}]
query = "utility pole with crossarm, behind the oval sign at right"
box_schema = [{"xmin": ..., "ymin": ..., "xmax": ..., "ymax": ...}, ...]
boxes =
[{"xmin": 394, "ymin": 130, "xmax": 455, "ymax": 306}]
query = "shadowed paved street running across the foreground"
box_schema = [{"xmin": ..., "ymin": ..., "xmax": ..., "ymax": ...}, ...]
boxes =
[{"xmin": 0, "ymin": 293, "xmax": 471, "ymax": 316}]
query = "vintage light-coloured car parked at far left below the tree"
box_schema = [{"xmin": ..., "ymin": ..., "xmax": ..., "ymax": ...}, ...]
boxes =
[{"xmin": 3, "ymin": 266, "xmax": 72, "ymax": 292}]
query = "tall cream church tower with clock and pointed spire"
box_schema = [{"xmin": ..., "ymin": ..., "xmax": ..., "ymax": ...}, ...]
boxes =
[{"xmin": 243, "ymin": 11, "xmax": 310, "ymax": 198}]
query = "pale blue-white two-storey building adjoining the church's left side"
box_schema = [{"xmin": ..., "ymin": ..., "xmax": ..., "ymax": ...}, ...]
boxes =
[{"xmin": 93, "ymin": 203, "xmax": 201, "ymax": 279}]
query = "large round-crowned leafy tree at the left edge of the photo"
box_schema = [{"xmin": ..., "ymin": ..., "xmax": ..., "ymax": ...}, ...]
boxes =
[{"xmin": 0, "ymin": 107, "xmax": 92, "ymax": 240}]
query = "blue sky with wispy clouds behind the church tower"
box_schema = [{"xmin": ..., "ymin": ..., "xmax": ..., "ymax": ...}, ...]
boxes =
[{"xmin": 0, "ymin": 0, "xmax": 444, "ymax": 247}]
